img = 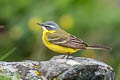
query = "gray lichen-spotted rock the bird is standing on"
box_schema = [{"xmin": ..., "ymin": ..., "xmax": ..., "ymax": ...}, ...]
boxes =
[{"xmin": 0, "ymin": 55, "xmax": 114, "ymax": 80}]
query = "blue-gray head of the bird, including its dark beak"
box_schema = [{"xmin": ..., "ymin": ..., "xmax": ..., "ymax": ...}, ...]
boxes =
[{"xmin": 37, "ymin": 21, "xmax": 59, "ymax": 30}]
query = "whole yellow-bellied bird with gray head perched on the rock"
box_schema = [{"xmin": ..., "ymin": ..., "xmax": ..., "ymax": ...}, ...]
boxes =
[{"xmin": 37, "ymin": 21, "xmax": 111, "ymax": 58}]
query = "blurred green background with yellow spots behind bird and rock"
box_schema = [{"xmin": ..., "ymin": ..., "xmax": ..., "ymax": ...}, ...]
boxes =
[{"xmin": 0, "ymin": 0, "xmax": 120, "ymax": 80}]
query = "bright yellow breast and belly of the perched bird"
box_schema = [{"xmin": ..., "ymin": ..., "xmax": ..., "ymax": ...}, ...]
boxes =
[{"xmin": 42, "ymin": 31, "xmax": 79, "ymax": 54}]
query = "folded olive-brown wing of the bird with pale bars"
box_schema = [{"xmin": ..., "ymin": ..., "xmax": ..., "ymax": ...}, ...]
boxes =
[{"xmin": 48, "ymin": 29, "xmax": 88, "ymax": 49}]
